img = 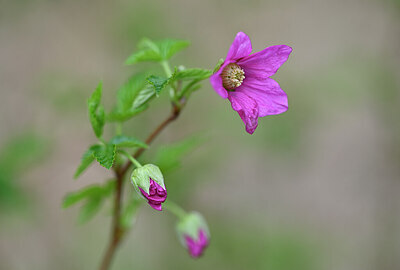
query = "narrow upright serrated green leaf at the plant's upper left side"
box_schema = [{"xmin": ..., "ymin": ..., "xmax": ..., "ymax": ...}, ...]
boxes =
[{"xmin": 88, "ymin": 82, "xmax": 105, "ymax": 138}]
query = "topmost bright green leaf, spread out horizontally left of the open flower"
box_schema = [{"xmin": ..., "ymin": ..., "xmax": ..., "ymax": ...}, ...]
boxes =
[{"xmin": 125, "ymin": 38, "xmax": 190, "ymax": 65}]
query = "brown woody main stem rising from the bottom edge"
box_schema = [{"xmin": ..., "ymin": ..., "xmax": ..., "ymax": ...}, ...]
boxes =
[{"xmin": 100, "ymin": 101, "xmax": 185, "ymax": 270}]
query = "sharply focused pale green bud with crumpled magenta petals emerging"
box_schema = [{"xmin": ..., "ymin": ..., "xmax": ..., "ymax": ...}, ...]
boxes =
[{"xmin": 131, "ymin": 164, "xmax": 167, "ymax": 211}]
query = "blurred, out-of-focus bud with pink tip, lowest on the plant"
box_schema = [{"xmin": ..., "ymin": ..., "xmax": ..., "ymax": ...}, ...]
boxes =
[{"xmin": 177, "ymin": 212, "xmax": 210, "ymax": 258}]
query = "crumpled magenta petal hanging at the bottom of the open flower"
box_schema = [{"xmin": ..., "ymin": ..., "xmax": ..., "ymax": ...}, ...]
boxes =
[{"xmin": 228, "ymin": 91, "xmax": 258, "ymax": 134}]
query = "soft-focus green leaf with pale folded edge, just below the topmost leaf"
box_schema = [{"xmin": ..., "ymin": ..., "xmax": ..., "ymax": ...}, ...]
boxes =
[{"xmin": 107, "ymin": 74, "xmax": 155, "ymax": 122}]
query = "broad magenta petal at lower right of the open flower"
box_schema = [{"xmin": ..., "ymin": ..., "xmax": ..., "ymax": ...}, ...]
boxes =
[{"xmin": 236, "ymin": 78, "xmax": 288, "ymax": 117}]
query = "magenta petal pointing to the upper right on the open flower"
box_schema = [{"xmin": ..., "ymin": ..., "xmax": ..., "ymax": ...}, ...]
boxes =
[{"xmin": 237, "ymin": 45, "xmax": 292, "ymax": 78}]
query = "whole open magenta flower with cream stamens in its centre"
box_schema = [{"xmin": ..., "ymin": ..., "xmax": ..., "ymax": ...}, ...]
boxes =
[{"xmin": 210, "ymin": 32, "xmax": 292, "ymax": 134}]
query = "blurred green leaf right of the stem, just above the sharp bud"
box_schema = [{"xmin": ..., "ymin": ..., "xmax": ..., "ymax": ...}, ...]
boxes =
[{"xmin": 154, "ymin": 137, "xmax": 203, "ymax": 173}]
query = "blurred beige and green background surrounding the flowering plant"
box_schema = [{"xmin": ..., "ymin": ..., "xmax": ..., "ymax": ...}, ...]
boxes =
[{"xmin": 0, "ymin": 0, "xmax": 400, "ymax": 270}]
